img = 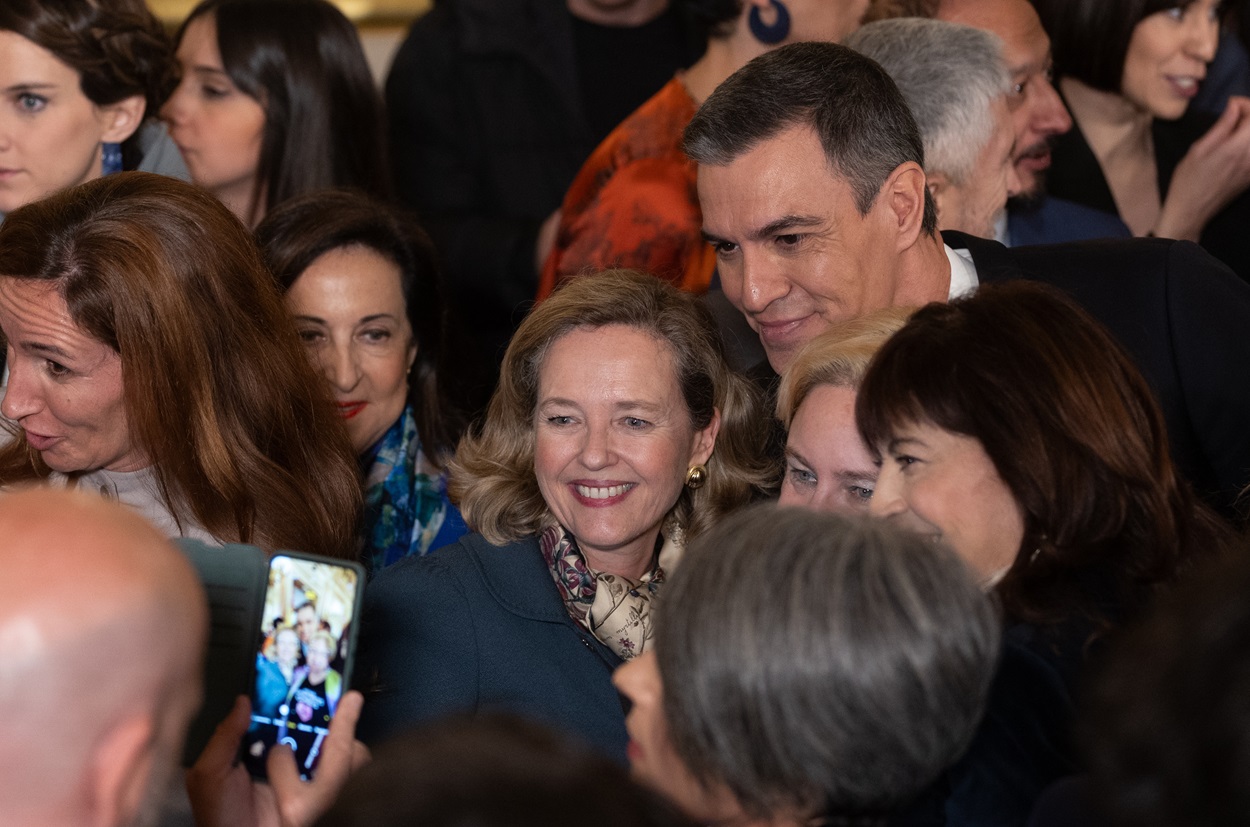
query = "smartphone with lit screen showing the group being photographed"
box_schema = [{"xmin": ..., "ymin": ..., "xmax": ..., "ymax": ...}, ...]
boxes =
[{"xmin": 243, "ymin": 552, "xmax": 364, "ymax": 781}]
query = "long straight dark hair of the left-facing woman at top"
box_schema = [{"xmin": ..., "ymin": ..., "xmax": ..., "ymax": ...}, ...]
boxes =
[{"xmin": 176, "ymin": 0, "xmax": 390, "ymax": 224}]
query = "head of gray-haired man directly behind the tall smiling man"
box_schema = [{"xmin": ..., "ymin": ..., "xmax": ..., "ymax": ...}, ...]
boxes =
[{"xmin": 845, "ymin": 17, "xmax": 1020, "ymax": 239}]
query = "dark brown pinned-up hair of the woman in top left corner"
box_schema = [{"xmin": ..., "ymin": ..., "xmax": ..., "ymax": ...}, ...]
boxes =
[{"xmin": 0, "ymin": 0, "xmax": 175, "ymax": 167}]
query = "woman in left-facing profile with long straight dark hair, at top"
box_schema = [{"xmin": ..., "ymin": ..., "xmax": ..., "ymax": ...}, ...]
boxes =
[{"xmin": 161, "ymin": 0, "xmax": 390, "ymax": 226}]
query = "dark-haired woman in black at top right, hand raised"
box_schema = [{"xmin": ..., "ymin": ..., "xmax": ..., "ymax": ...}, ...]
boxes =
[{"xmin": 1033, "ymin": 0, "xmax": 1250, "ymax": 280}]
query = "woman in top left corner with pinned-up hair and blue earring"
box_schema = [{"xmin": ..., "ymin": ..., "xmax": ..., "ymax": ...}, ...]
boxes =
[{"xmin": 0, "ymin": 0, "xmax": 186, "ymax": 220}]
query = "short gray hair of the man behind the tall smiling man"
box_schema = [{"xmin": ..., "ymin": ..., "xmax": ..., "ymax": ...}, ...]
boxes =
[{"xmin": 846, "ymin": 17, "xmax": 1011, "ymax": 185}]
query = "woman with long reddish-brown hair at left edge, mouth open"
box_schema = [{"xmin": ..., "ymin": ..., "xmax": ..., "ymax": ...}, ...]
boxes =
[{"xmin": 0, "ymin": 172, "xmax": 360, "ymax": 557}]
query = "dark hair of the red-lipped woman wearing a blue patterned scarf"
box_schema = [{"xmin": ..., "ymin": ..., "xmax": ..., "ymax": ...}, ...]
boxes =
[{"xmin": 256, "ymin": 190, "xmax": 468, "ymax": 465}]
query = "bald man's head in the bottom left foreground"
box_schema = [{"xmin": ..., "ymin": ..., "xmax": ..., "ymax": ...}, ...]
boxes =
[{"xmin": 0, "ymin": 488, "xmax": 208, "ymax": 825}]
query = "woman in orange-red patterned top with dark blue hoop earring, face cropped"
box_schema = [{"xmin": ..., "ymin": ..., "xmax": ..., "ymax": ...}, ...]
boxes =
[{"xmin": 539, "ymin": 0, "xmax": 869, "ymax": 300}]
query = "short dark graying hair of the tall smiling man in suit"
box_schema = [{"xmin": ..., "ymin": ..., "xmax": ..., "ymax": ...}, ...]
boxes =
[{"xmin": 681, "ymin": 42, "xmax": 938, "ymax": 235}]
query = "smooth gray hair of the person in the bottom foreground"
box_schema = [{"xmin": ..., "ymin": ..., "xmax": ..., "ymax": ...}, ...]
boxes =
[{"xmin": 655, "ymin": 505, "xmax": 1001, "ymax": 817}]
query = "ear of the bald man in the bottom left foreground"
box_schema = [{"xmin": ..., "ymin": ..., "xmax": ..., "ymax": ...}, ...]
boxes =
[{"xmin": 88, "ymin": 713, "xmax": 156, "ymax": 826}]
